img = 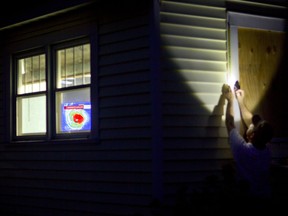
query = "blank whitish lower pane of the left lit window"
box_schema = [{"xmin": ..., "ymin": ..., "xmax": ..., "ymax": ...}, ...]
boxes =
[{"xmin": 16, "ymin": 95, "xmax": 46, "ymax": 136}]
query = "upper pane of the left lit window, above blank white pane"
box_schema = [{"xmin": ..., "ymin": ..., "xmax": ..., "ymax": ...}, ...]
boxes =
[{"xmin": 17, "ymin": 54, "xmax": 46, "ymax": 94}]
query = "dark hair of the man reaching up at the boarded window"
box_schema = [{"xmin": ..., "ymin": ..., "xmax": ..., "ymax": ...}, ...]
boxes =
[{"xmin": 252, "ymin": 120, "xmax": 273, "ymax": 148}]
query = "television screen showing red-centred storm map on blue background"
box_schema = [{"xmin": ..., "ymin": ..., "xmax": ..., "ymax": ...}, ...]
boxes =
[{"xmin": 61, "ymin": 102, "xmax": 91, "ymax": 132}]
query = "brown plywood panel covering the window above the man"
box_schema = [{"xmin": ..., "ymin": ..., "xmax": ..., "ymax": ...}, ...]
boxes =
[{"xmin": 238, "ymin": 28, "xmax": 285, "ymax": 136}]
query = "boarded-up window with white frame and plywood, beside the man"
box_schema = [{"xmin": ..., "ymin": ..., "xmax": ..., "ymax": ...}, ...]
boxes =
[{"xmin": 228, "ymin": 12, "xmax": 288, "ymax": 140}]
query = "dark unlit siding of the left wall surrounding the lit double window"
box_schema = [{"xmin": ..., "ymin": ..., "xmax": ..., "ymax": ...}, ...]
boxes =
[{"xmin": 0, "ymin": 2, "xmax": 152, "ymax": 216}]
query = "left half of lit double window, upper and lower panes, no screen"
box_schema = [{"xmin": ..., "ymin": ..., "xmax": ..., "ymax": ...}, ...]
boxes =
[{"xmin": 16, "ymin": 54, "xmax": 47, "ymax": 136}]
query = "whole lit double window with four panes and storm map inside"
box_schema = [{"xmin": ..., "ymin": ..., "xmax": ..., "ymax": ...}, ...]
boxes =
[{"xmin": 14, "ymin": 41, "xmax": 92, "ymax": 140}]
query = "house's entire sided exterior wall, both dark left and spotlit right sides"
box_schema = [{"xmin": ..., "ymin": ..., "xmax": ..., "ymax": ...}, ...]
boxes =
[{"xmin": 0, "ymin": 0, "xmax": 288, "ymax": 216}]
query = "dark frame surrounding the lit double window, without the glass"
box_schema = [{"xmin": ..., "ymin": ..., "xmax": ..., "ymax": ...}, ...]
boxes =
[{"xmin": 10, "ymin": 36, "xmax": 98, "ymax": 142}]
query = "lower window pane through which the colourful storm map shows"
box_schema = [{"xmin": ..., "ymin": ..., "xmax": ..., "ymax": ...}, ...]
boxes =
[{"xmin": 56, "ymin": 88, "xmax": 91, "ymax": 133}]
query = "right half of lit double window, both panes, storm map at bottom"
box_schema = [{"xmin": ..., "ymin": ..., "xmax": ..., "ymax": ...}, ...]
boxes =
[{"xmin": 56, "ymin": 44, "xmax": 91, "ymax": 133}]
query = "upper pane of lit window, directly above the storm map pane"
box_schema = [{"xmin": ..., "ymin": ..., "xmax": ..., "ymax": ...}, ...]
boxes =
[{"xmin": 56, "ymin": 44, "xmax": 90, "ymax": 88}]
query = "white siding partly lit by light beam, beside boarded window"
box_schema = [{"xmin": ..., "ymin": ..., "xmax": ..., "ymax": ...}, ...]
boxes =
[{"xmin": 160, "ymin": 0, "xmax": 287, "ymax": 207}]
